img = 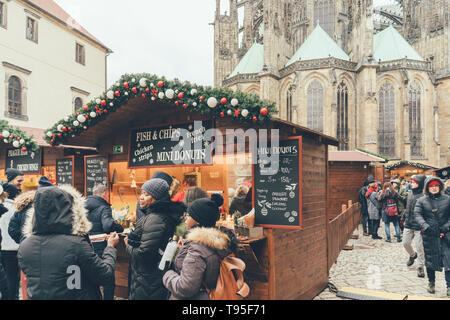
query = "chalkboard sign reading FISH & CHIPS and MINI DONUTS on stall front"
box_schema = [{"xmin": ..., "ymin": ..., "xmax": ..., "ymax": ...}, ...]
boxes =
[{"xmin": 128, "ymin": 120, "xmax": 212, "ymax": 168}]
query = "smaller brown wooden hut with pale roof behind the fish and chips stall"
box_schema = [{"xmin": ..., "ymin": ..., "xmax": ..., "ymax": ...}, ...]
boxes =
[{"xmin": 328, "ymin": 150, "xmax": 385, "ymax": 220}]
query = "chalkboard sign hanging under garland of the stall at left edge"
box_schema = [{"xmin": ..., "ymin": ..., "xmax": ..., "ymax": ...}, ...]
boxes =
[{"xmin": 6, "ymin": 149, "xmax": 41, "ymax": 174}]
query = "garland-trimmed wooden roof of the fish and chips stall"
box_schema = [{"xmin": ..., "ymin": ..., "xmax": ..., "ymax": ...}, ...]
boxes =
[{"xmin": 45, "ymin": 74, "xmax": 339, "ymax": 148}]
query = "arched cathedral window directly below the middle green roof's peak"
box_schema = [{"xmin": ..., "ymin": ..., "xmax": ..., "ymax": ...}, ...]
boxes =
[{"xmin": 307, "ymin": 80, "xmax": 323, "ymax": 132}]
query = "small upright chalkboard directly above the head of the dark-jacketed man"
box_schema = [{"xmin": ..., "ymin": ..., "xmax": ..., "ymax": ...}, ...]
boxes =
[{"xmin": 84, "ymin": 156, "xmax": 108, "ymax": 196}]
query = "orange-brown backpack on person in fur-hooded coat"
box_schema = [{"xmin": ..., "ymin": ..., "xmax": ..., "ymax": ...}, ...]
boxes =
[{"xmin": 205, "ymin": 254, "xmax": 250, "ymax": 300}]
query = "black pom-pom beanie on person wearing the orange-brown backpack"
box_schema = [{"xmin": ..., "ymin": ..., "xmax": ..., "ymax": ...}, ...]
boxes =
[{"xmin": 188, "ymin": 193, "xmax": 223, "ymax": 228}]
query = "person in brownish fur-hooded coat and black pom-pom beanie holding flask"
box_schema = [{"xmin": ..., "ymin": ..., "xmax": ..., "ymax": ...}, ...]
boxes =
[{"xmin": 163, "ymin": 194, "xmax": 236, "ymax": 300}]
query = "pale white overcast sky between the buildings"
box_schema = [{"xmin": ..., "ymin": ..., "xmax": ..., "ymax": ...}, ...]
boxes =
[{"xmin": 55, "ymin": 0, "xmax": 393, "ymax": 86}]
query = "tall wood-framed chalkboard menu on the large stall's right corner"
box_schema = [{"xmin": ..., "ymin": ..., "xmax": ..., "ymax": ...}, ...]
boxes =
[{"xmin": 253, "ymin": 137, "xmax": 302, "ymax": 229}]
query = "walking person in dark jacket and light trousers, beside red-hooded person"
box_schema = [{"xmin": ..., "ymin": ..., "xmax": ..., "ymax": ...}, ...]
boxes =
[{"xmin": 402, "ymin": 174, "xmax": 426, "ymax": 278}]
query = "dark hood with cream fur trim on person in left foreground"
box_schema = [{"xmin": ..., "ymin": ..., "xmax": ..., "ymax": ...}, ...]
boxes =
[{"xmin": 23, "ymin": 185, "xmax": 92, "ymax": 237}]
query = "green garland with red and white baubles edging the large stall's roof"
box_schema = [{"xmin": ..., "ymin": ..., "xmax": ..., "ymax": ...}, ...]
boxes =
[{"xmin": 44, "ymin": 73, "xmax": 276, "ymax": 147}]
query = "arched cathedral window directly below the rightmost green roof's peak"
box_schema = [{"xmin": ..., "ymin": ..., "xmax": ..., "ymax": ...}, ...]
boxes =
[{"xmin": 378, "ymin": 82, "xmax": 395, "ymax": 157}]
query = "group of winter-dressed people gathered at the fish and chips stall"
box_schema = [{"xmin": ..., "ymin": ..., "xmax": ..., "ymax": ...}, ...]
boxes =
[{"xmin": 0, "ymin": 169, "xmax": 243, "ymax": 300}]
